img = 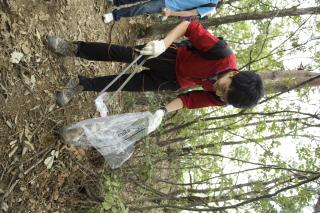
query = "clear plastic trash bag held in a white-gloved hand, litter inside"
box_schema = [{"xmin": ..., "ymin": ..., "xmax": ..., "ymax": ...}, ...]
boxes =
[{"xmin": 61, "ymin": 112, "xmax": 163, "ymax": 169}]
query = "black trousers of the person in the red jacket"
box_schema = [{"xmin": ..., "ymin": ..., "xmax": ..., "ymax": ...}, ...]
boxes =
[{"xmin": 77, "ymin": 42, "xmax": 179, "ymax": 91}]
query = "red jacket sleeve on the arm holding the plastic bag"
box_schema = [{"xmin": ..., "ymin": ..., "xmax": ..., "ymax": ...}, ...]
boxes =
[{"xmin": 178, "ymin": 90, "xmax": 226, "ymax": 109}]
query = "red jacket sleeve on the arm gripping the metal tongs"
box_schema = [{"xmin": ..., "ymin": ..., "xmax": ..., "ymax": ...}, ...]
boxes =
[{"xmin": 185, "ymin": 21, "xmax": 219, "ymax": 51}]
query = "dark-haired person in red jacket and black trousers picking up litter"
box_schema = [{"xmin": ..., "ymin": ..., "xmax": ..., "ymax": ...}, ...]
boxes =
[{"xmin": 48, "ymin": 21, "xmax": 264, "ymax": 116}]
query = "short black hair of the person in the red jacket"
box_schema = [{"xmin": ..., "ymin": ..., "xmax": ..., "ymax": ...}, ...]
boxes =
[{"xmin": 227, "ymin": 71, "xmax": 264, "ymax": 108}]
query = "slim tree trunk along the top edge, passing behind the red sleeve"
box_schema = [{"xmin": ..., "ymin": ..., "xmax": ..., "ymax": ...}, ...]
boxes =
[{"xmin": 139, "ymin": 7, "xmax": 320, "ymax": 37}]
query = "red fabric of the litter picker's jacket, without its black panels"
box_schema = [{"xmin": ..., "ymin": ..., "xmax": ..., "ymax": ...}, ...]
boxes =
[{"xmin": 176, "ymin": 21, "xmax": 238, "ymax": 109}]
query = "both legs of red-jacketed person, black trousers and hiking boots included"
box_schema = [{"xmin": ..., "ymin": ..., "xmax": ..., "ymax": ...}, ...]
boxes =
[{"xmin": 48, "ymin": 38, "xmax": 179, "ymax": 106}]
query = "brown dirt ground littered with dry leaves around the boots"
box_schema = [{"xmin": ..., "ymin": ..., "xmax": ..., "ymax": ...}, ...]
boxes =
[{"xmin": 0, "ymin": 0, "xmax": 156, "ymax": 212}]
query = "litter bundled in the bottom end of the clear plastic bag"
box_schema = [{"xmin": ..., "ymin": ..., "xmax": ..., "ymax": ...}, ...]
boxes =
[{"xmin": 58, "ymin": 127, "xmax": 84, "ymax": 145}]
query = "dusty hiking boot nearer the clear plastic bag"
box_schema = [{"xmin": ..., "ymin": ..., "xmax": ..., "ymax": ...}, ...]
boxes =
[{"xmin": 56, "ymin": 78, "xmax": 83, "ymax": 107}]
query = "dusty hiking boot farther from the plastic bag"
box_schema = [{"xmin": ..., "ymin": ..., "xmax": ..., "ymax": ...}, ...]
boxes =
[{"xmin": 48, "ymin": 36, "xmax": 78, "ymax": 56}]
